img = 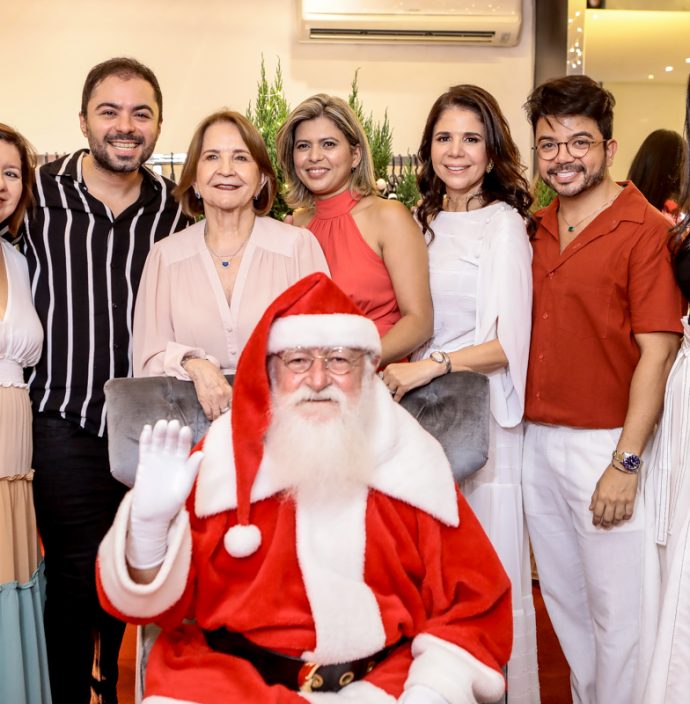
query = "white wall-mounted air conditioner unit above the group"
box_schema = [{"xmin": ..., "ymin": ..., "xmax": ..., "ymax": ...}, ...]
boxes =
[{"xmin": 300, "ymin": 0, "xmax": 522, "ymax": 46}]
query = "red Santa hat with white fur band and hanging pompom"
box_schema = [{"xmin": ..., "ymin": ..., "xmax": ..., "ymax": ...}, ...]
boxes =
[{"xmin": 224, "ymin": 273, "xmax": 381, "ymax": 557}]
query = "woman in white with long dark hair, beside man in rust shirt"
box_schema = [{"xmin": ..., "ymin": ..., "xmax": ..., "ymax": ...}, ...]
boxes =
[{"xmin": 383, "ymin": 85, "xmax": 539, "ymax": 704}]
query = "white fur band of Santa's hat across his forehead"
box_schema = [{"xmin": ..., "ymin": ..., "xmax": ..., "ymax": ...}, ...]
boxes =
[{"xmin": 267, "ymin": 313, "xmax": 381, "ymax": 355}]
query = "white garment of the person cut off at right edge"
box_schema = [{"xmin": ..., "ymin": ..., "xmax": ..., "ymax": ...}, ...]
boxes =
[{"xmin": 640, "ymin": 318, "xmax": 690, "ymax": 704}]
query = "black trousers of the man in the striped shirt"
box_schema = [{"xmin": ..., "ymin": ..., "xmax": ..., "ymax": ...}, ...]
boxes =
[{"xmin": 33, "ymin": 413, "xmax": 126, "ymax": 704}]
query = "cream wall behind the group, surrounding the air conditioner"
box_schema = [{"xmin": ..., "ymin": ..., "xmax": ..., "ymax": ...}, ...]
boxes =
[{"xmin": 0, "ymin": 0, "xmax": 534, "ymax": 161}]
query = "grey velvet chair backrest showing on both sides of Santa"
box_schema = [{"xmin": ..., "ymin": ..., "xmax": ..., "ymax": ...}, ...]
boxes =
[{"xmin": 105, "ymin": 372, "xmax": 489, "ymax": 486}]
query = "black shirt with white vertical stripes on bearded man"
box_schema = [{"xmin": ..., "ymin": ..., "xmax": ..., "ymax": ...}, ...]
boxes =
[{"xmin": 23, "ymin": 150, "xmax": 189, "ymax": 436}]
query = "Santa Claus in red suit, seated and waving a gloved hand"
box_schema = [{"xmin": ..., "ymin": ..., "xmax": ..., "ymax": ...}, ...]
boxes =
[{"xmin": 98, "ymin": 274, "xmax": 512, "ymax": 704}]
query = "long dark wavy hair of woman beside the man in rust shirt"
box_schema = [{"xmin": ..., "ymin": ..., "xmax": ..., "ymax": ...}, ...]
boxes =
[{"xmin": 417, "ymin": 84, "xmax": 534, "ymax": 239}]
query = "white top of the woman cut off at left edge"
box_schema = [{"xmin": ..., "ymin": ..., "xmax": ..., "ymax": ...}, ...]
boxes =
[{"xmin": 0, "ymin": 238, "xmax": 43, "ymax": 388}]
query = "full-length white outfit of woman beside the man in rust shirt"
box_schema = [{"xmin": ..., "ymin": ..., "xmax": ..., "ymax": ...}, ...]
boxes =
[{"xmin": 413, "ymin": 202, "xmax": 539, "ymax": 704}]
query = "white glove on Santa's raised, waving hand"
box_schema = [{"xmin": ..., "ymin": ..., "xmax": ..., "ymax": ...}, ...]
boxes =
[{"xmin": 125, "ymin": 420, "xmax": 204, "ymax": 569}]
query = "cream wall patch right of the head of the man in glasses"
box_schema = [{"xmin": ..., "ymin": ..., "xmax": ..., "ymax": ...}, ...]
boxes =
[{"xmin": 604, "ymin": 82, "xmax": 685, "ymax": 181}]
